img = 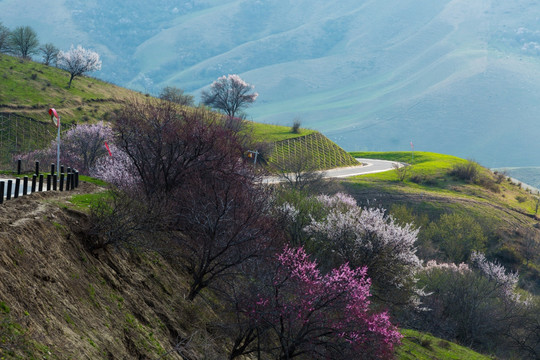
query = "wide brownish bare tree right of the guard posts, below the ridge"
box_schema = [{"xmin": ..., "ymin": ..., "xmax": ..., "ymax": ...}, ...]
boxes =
[{"xmin": 114, "ymin": 100, "xmax": 225, "ymax": 197}]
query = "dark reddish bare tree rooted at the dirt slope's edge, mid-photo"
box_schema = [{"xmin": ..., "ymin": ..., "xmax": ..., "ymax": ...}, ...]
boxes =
[{"xmin": 176, "ymin": 169, "xmax": 277, "ymax": 300}]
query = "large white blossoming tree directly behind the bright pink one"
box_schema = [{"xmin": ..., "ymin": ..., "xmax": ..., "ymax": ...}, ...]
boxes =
[{"xmin": 282, "ymin": 193, "xmax": 421, "ymax": 307}]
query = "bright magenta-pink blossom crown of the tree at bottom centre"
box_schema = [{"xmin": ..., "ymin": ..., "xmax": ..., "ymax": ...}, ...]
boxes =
[{"xmin": 249, "ymin": 247, "xmax": 402, "ymax": 358}]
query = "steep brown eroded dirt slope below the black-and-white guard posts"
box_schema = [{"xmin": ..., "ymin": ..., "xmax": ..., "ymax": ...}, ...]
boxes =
[{"xmin": 0, "ymin": 184, "xmax": 219, "ymax": 359}]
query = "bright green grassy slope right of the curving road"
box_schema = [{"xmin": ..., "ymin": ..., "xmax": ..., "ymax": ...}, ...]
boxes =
[{"xmin": 343, "ymin": 152, "xmax": 540, "ymax": 294}]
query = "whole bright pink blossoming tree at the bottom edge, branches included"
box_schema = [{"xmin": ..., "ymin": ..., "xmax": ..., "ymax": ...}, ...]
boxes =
[{"xmin": 231, "ymin": 247, "xmax": 402, "ymax": 359}]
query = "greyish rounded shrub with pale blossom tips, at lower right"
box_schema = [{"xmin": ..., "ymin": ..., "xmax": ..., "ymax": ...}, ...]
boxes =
[{"xmin": 419, "ymin": 253, "xmax": 525, "ymax": 351}]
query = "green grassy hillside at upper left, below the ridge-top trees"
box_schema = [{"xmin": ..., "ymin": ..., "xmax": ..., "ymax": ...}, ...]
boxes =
[{"xmin": 0, "ymin": 54, "xmax": 144, "ymax": 167}]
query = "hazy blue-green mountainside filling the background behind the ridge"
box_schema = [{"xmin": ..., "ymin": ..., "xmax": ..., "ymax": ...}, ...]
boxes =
[{"xmin": 0, "ymin": 0, "xmax": 540, "ymax": 167}]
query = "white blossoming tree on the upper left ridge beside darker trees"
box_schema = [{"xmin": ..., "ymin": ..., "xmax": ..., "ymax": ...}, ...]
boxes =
[{"xmin": 56, "ymin": 45, "xmax": 101, "ymax": 88}]
